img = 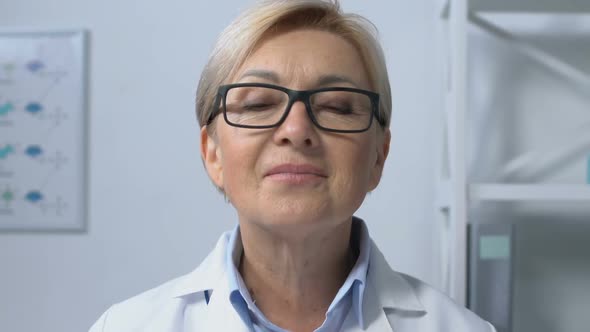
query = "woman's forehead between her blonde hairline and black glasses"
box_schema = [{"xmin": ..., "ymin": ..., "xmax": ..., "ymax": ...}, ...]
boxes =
[{"xmin": 232, "ymin": 29, "xmax": 369, "ymax": 89}]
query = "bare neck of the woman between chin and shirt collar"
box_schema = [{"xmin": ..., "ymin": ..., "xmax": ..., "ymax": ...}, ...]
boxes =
[{"xmin": 239, "ymin": 220, "xmax": 356, "ymax": 330}]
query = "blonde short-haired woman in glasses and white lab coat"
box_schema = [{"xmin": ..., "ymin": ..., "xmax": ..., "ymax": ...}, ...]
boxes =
[{"xmin": 91, "ymin": 0, "xmax": 494, "ymax": 332}]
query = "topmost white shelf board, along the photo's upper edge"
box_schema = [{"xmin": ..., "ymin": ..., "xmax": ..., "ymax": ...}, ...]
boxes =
[{"xmin": 468, "ymin": 0, "xmax": 590, "ymax": 14}]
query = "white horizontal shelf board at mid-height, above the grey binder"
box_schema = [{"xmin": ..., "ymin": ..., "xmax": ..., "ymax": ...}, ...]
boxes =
[{"xmin": 468, "ymin": 183, "xmax": 590, "ymax": 202}]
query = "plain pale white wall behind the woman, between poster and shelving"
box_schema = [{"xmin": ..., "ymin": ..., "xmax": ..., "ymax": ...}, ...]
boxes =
[{"xmin": 0, "ymin": 0, "xmax": 440, "ymax": 332}]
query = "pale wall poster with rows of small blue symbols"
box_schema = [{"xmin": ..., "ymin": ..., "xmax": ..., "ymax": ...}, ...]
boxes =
[{"xmin": 0, "ymin": 30, "xmax": 87, "ymax": 232}]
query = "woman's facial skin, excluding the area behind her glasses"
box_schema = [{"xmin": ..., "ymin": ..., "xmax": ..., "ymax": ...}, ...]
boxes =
[{"xmin": 201, "ymin": 30, "xmax": 389, "ymax": 236}]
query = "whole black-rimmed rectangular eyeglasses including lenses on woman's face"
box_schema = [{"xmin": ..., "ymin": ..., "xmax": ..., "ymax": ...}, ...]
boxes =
[{"xmin": 207, "ymin": 83, "xmax": 385, "ymax": 133}]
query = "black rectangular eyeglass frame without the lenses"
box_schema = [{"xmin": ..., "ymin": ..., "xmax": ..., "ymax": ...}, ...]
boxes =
[{"xmin": 207, "ymin": 83, "xmax": 385, "ymax": 133}]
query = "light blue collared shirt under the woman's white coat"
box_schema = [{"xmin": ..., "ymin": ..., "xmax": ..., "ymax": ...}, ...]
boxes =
[{"xmin": 226, "ymin": 217, "xmax": 371, "ymax": 332}]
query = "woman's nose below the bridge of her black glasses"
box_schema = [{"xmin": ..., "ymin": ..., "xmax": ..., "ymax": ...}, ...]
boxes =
[{"xmin": 274, "ymin": 101, "xmax": 318, "ymax": 148}]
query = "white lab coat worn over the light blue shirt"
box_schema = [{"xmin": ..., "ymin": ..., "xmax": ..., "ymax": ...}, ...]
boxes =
[{"xmin": 90, "ymin": 232, "xmax": 495, "ymax": 332}]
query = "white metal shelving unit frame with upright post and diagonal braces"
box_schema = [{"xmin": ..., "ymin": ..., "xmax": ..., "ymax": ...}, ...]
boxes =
[{"xmin": 434, "ymin": 0, "xmax": 590, "ymax": 304}]
